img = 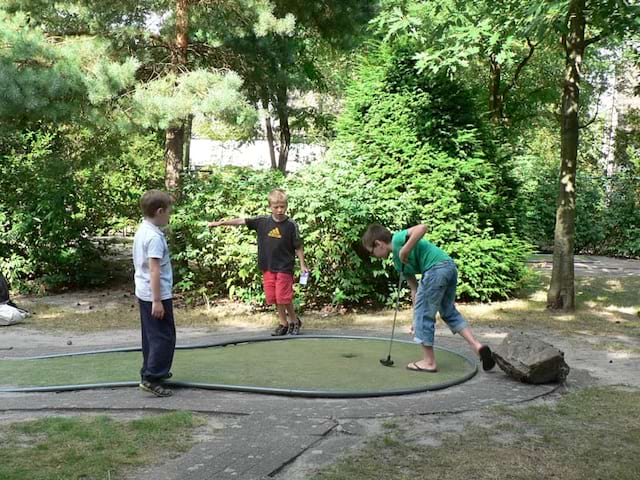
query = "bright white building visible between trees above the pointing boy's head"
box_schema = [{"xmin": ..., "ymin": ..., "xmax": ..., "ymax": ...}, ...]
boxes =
[{"xmin": 189, "ymin": 138, "xmax": 327, "ymax": 172}]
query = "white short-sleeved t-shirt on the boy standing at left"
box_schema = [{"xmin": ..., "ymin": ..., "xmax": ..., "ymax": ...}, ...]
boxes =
[{"xmin": 133, "ymin": 219, "xmax": 173, "ymax": 302}]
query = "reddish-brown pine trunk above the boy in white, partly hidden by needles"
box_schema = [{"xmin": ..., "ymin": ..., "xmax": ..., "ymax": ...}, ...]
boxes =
[{"xmin": 164, "ymin": 0, "xmax": 189, "ymax": 194}]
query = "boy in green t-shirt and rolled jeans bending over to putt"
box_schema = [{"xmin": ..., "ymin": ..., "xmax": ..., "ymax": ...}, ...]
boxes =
[{"xmin": 362, "ymin": 224, "xmax": 495, "ymax": 372}]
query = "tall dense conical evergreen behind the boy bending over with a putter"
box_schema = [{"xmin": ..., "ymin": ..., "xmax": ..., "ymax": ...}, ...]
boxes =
[{"xmin": 330, "ymin": 47, "xmax": 530, "ymax": 300}]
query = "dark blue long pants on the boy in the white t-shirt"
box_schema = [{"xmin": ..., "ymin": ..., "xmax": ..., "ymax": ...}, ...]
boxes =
[{"xmin": 138, "ymin": 299, "xmax": 176, "ymax": 382}]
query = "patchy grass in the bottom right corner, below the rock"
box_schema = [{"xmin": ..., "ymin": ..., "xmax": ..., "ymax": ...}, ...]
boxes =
[{"xmin": 313, "ymin": 387, "xmax": 640, "ymax": 480}]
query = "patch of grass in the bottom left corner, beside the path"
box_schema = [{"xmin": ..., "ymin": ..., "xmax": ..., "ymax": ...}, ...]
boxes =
[{"xmin": 0, "ymin": 412, "xmax": 205, "ymax": 480}]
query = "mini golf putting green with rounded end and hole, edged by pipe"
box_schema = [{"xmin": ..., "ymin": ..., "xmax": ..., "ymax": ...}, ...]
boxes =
[{"xmin": 0, "ymin": 335, "xmax": 477, "ymax": 397}]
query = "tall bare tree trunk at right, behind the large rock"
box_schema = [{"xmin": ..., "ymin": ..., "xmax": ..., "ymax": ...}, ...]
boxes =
[{"xmin": 547, "ymin": 0, "xmax": 585, "ymax": 311}]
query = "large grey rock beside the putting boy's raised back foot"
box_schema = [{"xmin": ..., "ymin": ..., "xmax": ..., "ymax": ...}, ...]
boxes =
[{"xmin": 493, "ymin": 333, "xmax": 569, "ymax": 383}]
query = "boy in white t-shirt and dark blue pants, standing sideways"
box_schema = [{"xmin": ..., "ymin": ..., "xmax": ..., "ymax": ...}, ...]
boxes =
[{"xmin": 133, "ymin": 190, "xmax": 176, "ymax": 397}]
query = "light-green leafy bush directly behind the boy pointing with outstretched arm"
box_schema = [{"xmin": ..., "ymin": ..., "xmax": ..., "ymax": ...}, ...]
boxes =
[{"xmin": 171, "ymin": 161, "xmax": 381, "ymax": 304}]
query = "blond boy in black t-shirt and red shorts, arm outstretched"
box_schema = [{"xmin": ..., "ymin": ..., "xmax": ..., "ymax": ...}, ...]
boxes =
[{"xmin": 209, "ymin": 189, "xmax": 308, "ymax": 336}]
